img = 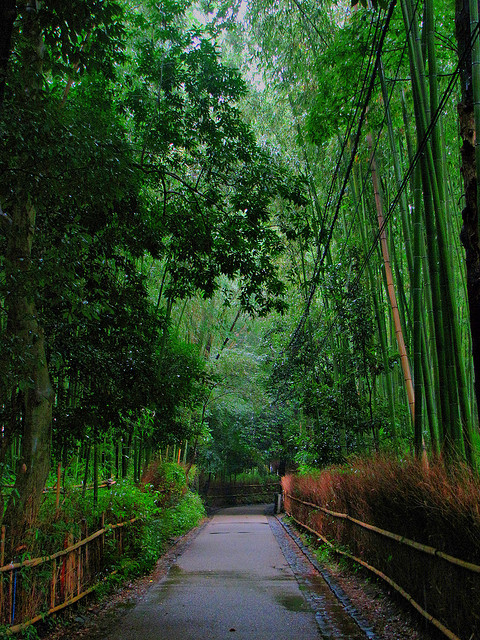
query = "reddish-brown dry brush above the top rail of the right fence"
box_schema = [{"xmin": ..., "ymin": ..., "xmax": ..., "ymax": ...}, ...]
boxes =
[{"xmin": 282, "ymin": 455, "xmax": 480, "ymax": 564}]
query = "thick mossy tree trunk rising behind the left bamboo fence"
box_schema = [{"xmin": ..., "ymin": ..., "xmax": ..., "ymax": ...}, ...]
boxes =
[{"xmin": 5, "ymin": 2, "xmax": 54, "ymax": 543}]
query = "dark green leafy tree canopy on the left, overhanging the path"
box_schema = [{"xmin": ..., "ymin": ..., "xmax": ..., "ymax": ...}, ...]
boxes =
[{"xmin": 0, "ymin": 0, "xmax": 305, "ymax": 520}]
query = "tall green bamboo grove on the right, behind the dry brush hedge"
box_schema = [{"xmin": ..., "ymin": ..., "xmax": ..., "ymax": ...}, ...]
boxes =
[{"xmin": 242, "ymin": 0, "xmax": 478, "ymax": 465}]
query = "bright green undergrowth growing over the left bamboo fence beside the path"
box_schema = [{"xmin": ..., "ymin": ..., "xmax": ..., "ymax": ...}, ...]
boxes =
[{"xmin": 14, "ymin": 463, "xmax": 205, "ymax": 624}]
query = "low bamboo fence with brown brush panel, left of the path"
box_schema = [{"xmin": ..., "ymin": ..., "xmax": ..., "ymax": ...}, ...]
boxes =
[{"xmin": 0, "ymin": 516, "xmax": 137, "ymax": 635}]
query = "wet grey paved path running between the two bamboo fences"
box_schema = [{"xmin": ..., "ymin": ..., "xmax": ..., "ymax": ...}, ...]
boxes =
[{"xmin": 100, "ymin": 506, "xmax": 320, "ymax": 640}]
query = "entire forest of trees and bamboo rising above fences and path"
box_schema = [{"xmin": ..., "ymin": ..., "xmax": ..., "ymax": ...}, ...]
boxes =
[{"xmin": 0, "ymin": 0, "xmax": 480, "ymax": 544}]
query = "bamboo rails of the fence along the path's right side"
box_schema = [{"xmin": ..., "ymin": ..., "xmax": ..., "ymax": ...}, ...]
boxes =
[{"xmin": 283, "ymin": 492, "xmax": 480, "ymax": 640}]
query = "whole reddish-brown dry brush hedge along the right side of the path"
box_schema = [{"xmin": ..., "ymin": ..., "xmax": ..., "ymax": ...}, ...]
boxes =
[{"xmin": 283, "ymin": 457, "xmax": 480, "ymax": 640}]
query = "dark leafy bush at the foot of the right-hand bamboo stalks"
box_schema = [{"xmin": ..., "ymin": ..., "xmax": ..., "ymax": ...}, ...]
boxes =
[{"xmin": 271, "ymin": 250, "xmax": 385, "ymax": 466}]
